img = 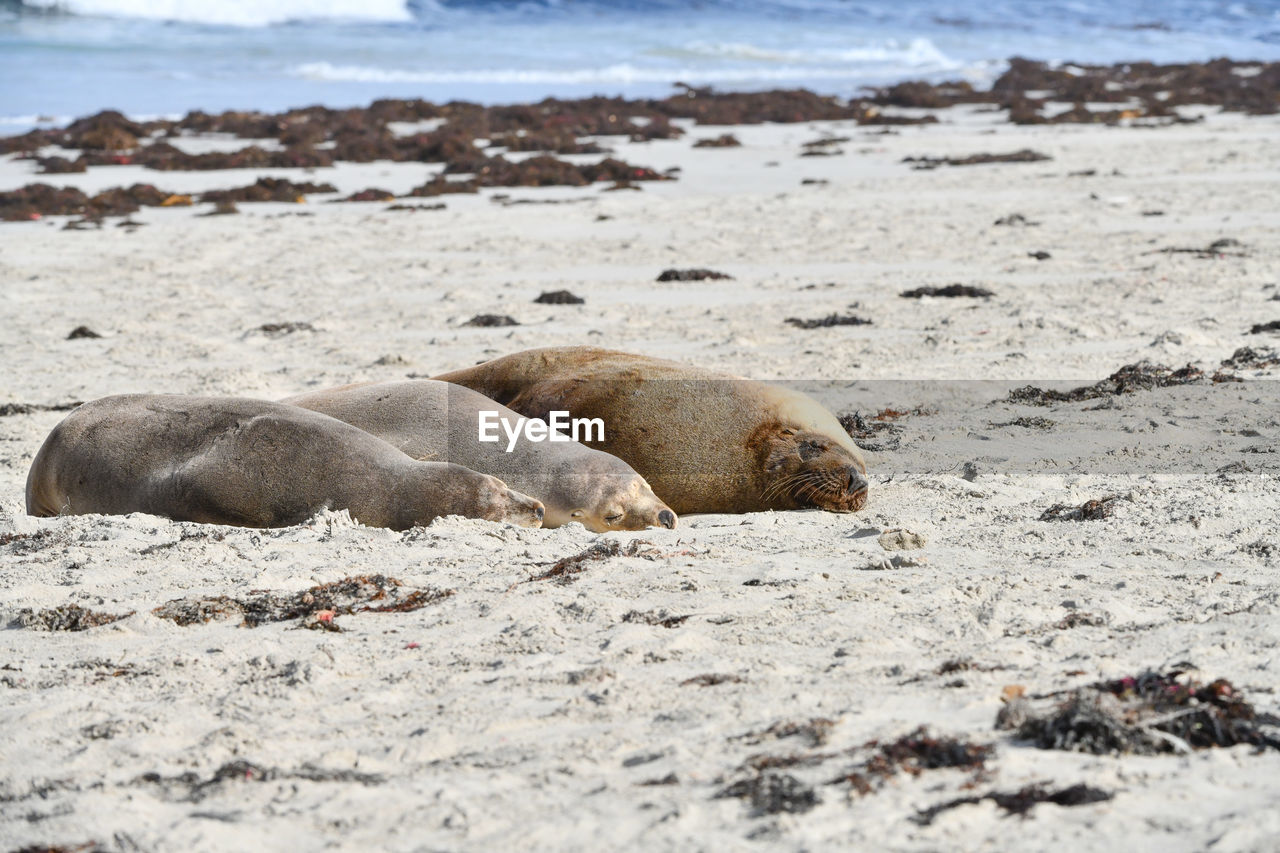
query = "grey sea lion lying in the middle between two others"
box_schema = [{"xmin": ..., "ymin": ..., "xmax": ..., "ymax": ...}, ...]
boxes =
[{"xmin": 282, "ymin": 379, "xmax": 676, "ymax": 533}]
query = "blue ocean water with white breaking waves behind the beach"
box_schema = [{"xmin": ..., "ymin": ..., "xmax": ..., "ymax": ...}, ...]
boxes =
[{"xmin": 0, "ymin": 0, "xmax": 1280, "ymax": 133}]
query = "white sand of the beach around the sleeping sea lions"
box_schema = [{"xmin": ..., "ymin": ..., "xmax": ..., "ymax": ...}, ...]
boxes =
[{"xmin": 0, "ymin": 110, "xmax": 1280, "ymax": 850}]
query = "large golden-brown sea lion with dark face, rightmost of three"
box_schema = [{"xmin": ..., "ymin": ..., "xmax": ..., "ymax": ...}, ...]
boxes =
[{"xmin": 435, "ymin": 347, "xmax": 868, "ymax": 514}]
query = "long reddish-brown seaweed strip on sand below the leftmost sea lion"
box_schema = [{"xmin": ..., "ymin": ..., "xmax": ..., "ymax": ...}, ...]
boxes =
[{"xmin": 151, "ymin": 575, "xmax": 454, "ymax": 628}]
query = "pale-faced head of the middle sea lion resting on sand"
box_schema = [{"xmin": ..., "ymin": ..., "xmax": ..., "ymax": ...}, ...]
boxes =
[{"xmin": 543, "ymin": 466, "xmax": 676, "ymax": 533}]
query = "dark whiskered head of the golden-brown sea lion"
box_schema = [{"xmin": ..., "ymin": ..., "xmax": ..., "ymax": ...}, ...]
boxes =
[{"xmin": 764, "ymin": 424, "xmax": 868, "ymax": 512}]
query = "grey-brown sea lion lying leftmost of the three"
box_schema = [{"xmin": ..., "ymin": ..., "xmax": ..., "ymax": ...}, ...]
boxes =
[{"xmin": 27, "ymin": 394, "xmax": 543, "ymax": 530}]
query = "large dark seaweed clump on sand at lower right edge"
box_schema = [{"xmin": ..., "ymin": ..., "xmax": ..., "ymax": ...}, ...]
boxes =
[{"xmin": 996, "ymin": 663, "xmax": 1280, "ymax": 756}]
